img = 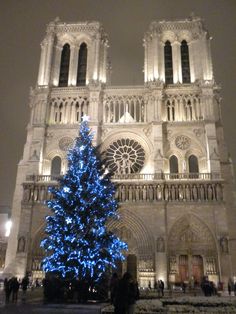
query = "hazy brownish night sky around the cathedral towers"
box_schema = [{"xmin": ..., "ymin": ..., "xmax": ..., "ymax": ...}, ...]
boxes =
[{"xmin": 0, "ymin": 0, "xmax": 236, "ymax": 211}]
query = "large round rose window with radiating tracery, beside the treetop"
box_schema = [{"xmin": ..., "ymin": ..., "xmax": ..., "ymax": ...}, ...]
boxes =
[{"xmin": 106, "ymin": 138, "xmax": 145, "ymax": 174}]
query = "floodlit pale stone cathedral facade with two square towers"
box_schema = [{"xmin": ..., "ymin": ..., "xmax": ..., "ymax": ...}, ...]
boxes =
[{"xmin": 5, "ymin": 17, "xmax": 236, "ymax": 287}]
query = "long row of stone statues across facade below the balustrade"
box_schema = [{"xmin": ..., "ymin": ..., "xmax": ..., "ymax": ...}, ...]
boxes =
[{"xmin": 23, "ymin": 183, "xmax": 223, "ymax": 202}]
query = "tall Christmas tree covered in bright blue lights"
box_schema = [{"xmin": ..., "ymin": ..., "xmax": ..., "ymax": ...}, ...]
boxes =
[{"xmin": 41, "ymin": 118, "xmax": 127, "ymax": 282}]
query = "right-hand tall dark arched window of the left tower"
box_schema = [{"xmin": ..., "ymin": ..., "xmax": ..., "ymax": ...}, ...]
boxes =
[{"xmin": 76, "ymin": 43, "xmax": 88, "ymax": 86}]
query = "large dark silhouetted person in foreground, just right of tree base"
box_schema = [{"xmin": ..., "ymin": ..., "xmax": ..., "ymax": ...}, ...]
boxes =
[{"xmin": 114, "ymin": 273, "xmax": 138, "ymax": 314}]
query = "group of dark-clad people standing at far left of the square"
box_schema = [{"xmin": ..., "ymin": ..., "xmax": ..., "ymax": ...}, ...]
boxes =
[{"xmin": 4, "ymin": 276, "xmax": 29, "ymax": 303}]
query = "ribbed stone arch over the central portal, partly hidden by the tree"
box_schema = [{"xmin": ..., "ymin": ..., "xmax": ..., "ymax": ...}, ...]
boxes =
[{"xmin": 108, "ymin": 209, "xmax": 154, "ymax": 256}]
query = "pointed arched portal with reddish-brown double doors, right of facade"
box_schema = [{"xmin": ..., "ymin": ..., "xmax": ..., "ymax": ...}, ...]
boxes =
[{"xmin": 168, "ymin": 214, "xmax": 218, "ymax": 284}]
